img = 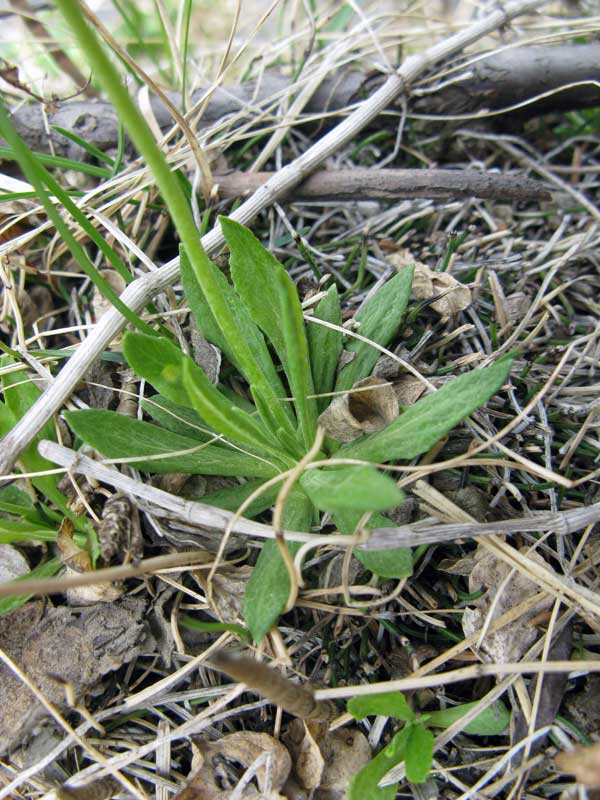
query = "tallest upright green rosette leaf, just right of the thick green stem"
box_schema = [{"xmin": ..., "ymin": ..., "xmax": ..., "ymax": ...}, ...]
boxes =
[{"xmin": 219, "ymin": 217, "xmax": 317, "ymax": 447}]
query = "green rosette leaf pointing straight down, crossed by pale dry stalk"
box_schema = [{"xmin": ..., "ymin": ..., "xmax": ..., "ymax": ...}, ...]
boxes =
[{"xmin": 244, "ymin": 490, "xmax": 314, "ymax": 642}]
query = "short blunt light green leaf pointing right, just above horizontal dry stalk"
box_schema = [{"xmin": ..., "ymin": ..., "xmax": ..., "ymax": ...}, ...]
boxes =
[{"xmin": 300, "ymin": 465, "xmax": 404, "ymax": 513}]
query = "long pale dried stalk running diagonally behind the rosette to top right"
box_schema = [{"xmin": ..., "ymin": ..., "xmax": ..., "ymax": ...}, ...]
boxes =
[{"xmin": 0, "ymin": 0, "xmax": 543, "ymax": 475}]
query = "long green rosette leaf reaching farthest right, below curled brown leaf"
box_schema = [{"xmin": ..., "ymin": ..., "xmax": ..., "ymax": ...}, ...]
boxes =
[{"xmin": 336, "ymin": 358, "xmax": 512, "ymax": 462}]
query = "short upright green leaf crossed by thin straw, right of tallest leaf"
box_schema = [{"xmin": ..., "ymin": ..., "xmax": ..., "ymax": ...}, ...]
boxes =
[{"xmin": 307, "ymin": 284, "xmax": 343, "ymax": 411}]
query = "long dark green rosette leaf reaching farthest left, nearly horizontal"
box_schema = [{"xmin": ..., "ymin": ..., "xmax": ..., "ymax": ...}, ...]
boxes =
[{"xmin": 64, "ymin": 409, "xmax": 278, "ymax": 478}]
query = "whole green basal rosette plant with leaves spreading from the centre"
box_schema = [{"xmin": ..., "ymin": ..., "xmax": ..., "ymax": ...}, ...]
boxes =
[{"xmin": 64, "ymin": 218, "xmax": 510, "ymax": 640}]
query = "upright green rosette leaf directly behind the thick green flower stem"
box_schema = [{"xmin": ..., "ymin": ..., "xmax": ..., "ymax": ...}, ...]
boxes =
[{"xmin": 180, "ymin": 248, "xmax": 300, "ymax": 444}]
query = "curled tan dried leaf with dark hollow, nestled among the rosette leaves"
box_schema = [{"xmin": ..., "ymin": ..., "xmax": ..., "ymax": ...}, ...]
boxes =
[{"xmin": 319, "ymin": 377, "xmax": 400, "ymax": 442}]
